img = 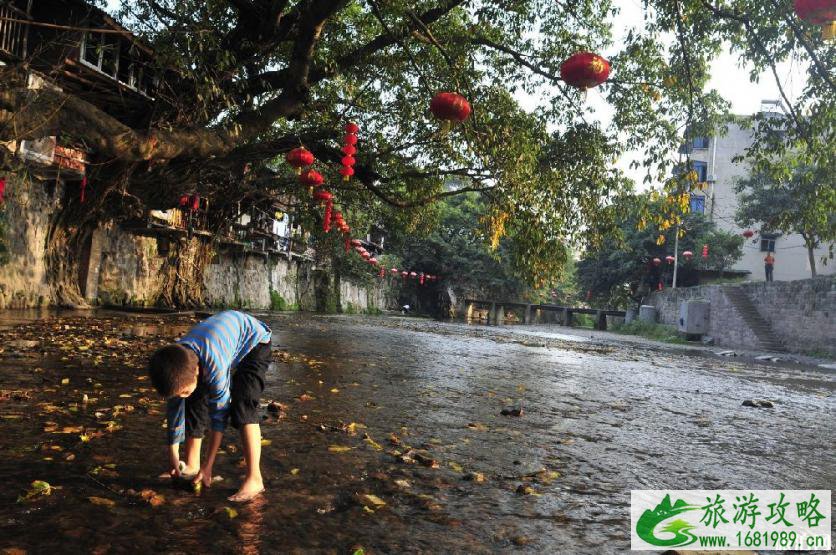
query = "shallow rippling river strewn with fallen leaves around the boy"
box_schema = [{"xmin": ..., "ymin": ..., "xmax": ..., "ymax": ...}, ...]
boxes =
[{"xmin": 0, "ymin": 314, "xmax": 836, "ymax": 554}]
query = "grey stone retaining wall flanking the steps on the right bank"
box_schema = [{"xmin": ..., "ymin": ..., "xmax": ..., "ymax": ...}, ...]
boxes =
[{"xmin": 649, "ymin": 276, "xmax": 836, "ymax": 355}]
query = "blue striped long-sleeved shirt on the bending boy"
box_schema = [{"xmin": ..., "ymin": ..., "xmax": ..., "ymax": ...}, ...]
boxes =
[{"xmin": 166, "ymin": 310, "xmax": 272, "ymax": 445}]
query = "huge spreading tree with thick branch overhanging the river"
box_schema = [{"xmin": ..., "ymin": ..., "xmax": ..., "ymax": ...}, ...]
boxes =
[{"xmin": 0, "ymin": 0, "xmax": 836, "ymax": 304}]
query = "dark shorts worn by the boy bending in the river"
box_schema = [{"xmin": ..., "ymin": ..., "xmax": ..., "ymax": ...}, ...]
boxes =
[{"xmin": 186, "ymin": 343, "xmax": 272, "ymax": 437}]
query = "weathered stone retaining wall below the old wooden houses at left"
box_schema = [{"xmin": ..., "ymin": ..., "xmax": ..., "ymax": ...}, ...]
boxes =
[{"xmin": 0, "ymin": 176, "xmax": 396, "ymax": 311}]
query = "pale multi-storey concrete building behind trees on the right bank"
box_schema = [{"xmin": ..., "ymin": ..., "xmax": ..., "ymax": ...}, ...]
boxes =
[{"xmin": 690, "ymin": 102, "xmax": 836, "ymax": 281}]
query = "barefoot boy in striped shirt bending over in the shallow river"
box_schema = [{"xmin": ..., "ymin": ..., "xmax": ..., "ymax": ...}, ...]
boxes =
[{"xmin": 148, "ymin": 310, "xmax": 272, "ymax": 502}]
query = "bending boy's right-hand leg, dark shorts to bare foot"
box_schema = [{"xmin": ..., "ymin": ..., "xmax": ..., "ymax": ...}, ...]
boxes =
[{"xmin": 229, "ymin": 344, "xmax": 271, "ymax": 501}]
